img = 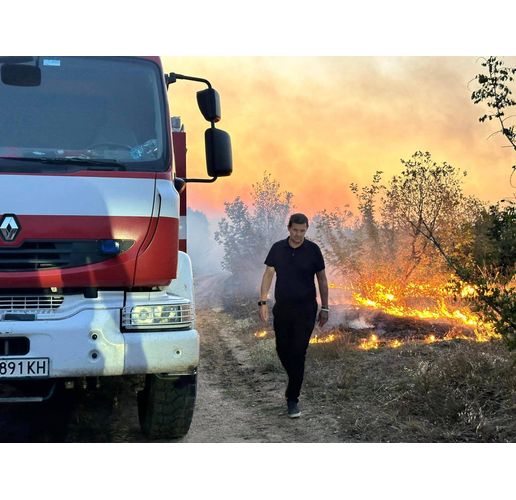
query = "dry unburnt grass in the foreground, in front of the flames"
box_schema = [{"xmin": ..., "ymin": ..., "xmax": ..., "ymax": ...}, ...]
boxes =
[{"xmin": 247, "ymin": 320, "xmax": 516, "ymax": 442}]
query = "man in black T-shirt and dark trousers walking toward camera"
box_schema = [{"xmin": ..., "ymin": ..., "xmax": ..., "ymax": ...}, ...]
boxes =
[{"xmin": 258, "ymin": 213, "xmax": 329, "ymax": 418}]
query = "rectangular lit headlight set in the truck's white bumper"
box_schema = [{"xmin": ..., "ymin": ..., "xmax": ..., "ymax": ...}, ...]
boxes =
[{"xmin": 122, "ymin": 303, "xmax": 193, "ymax": 330}]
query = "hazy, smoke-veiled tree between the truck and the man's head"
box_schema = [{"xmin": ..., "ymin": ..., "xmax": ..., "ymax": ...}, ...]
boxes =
[{"xmin": 215, "ymin": 172, "xmax": 293, "ymax": 289}]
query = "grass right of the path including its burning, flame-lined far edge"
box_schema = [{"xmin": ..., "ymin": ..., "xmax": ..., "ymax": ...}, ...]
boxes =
[{"xmin": 220, "ymin": 288, "xmax": 516, "ymax": 442}]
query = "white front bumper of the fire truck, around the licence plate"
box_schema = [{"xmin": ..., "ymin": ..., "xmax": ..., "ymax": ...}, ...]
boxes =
[{"xmin": 0, "ymin": 292, "xmax": 199, "ymax": 379}]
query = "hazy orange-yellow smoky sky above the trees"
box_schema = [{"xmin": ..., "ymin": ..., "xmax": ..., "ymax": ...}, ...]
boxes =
[{"xmin": 163, "ymin": 57, "xmax": 516, "ymax": 217}]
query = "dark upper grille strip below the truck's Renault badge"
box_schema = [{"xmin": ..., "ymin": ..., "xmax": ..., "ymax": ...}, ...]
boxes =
[{"xmin": 0, "ymin": 240, "xmax": 134, "ymax": 272}]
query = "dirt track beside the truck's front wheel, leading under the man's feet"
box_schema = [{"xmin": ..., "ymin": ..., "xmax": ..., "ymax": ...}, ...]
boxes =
[{"xmin": 179, "ymin": 310, "xmax": 337, "ymax": 443}]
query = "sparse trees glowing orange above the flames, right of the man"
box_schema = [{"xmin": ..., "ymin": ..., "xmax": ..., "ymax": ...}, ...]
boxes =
[{"xmin": 318, "ymin": 151, "xmax": 480, "ymax": 298}]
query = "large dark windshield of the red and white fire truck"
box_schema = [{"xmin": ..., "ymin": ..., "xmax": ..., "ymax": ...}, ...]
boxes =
[{"xmin": 0, "ymin": 56, "xmax": 170, "ymax": 171}]
